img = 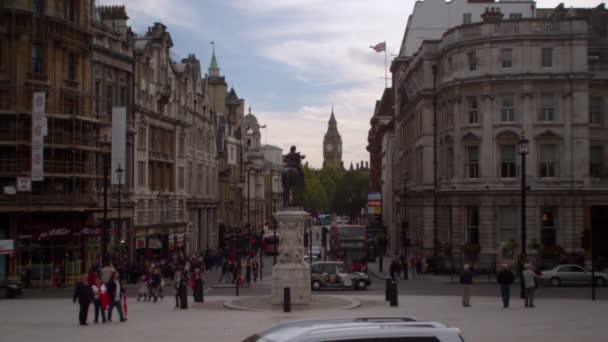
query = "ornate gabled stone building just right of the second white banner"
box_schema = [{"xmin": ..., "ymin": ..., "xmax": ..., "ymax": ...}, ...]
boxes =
[{"xmin": 134, "ymin": 23, "xmax": 219, "ymax": 256}]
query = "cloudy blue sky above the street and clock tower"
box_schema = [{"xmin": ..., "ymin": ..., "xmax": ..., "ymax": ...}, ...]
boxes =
[{"xmin": 97, "ymin": 0, "xmax": 601, "ymax": 168}]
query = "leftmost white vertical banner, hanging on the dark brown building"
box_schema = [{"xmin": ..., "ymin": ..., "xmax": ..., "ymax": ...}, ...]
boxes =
[{"xmin": 32, "ymin": 91, "xmax": 46, "ymax": 181}]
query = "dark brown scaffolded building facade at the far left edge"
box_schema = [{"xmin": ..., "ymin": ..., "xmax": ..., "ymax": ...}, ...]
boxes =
[{"xmin": 0, "ymin": 0, "xmax": 103, "ymax": 286}]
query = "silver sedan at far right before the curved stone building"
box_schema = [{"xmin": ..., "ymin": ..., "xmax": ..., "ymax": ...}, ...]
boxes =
[{"xmin": 537, "ymin": 265, "xmax": 608, "ymax": 286}]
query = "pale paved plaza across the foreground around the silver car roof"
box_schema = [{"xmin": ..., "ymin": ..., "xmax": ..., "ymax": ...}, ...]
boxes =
[{"xmin": 0, "ymin": 295, "xmax": 608, "ymax": 342}]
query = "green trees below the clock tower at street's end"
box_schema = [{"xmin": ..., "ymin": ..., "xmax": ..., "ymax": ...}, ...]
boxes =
[{"xmin": 299, "ymin": 168, "xmax": 369, "ymax": 218}]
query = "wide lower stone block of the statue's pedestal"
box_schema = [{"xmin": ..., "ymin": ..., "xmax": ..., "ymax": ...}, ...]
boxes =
[{"xmin": 270, "ymin": 263, "xmax": 311, "ymax": 305}]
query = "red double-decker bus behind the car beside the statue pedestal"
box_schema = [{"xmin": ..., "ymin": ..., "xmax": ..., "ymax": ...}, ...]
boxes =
[{"xmin": 329, "ymin": 224, "xmax": 367, "ymax": 272}]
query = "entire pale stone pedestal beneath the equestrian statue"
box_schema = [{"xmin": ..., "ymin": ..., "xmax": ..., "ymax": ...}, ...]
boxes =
[{"xmin": 271, "ymin": 208, "xmax": 311, "ymax": 305}]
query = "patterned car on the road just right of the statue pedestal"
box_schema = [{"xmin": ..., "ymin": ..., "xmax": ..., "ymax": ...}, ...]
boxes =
[{"xmin": 310, "ymin": 261, "xmax": 372, "ymax": 290}]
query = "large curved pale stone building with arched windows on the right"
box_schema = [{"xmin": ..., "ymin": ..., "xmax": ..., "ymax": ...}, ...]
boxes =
[{"xmin": 383, "ymin": 5, "xmax": 608, "ymax": 267}]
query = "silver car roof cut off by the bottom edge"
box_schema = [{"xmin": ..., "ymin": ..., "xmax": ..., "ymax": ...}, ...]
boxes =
[{"xmin": 243, "ymin": 317, "xmax": 464, "ymax": 342}]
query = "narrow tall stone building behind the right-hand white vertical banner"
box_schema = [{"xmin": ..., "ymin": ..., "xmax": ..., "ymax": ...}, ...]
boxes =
[{"xmin": 91, "ymin": 6, "xmax": 135, "ymax": 260}]
